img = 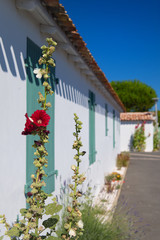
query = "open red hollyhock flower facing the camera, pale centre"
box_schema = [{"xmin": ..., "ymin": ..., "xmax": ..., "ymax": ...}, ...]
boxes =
[{"xmin": 31, "ymin": 110, "xmax": 50, "ymax": 127}]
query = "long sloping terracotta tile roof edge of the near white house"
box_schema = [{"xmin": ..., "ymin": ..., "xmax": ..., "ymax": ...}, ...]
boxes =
[{"xmin": 41, "ymin": 0, "xmax": 126, "ymax": 111}]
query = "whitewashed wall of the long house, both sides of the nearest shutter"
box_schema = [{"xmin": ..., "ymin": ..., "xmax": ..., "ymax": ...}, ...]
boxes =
[{"xmin": 0, "ymin": 0, "xmax": 120, "ymax": 227}]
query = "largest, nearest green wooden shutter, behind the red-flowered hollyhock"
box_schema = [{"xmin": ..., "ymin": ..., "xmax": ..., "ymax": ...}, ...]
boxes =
[{"xmin": 25, "ymin": 38, "xmax": 56, "ymax": 193}]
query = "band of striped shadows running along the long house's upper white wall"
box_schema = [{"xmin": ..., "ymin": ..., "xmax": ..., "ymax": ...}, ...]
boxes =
[{"xmin": 0, "ymin": 34, "xmax": 116, "ymax": 120}]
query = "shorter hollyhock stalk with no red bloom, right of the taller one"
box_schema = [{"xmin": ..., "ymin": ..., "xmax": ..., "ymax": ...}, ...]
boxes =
[{"xmin": 62, "ymin": 114, "xmax": 86, "ymax": 240}]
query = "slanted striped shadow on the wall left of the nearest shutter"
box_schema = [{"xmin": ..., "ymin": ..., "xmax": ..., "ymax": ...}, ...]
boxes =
[{"xmin": 0, "ymin": 37, "xmax": 26, "ymax": 80}]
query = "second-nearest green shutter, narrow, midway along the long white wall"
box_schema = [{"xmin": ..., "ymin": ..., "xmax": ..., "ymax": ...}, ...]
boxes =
[{"xmin": 89, "ymin": 91, "xmax": 96, "ymax": 164}]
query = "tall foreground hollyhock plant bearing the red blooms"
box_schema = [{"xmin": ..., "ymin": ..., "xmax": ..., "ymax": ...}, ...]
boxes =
[{"xmin": 0, "ymin": 38, "xmax": 62, "ymax": 240}]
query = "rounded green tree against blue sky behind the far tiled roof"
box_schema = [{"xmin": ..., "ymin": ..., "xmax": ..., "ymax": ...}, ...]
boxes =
[{"xmin": 111, "ymin": 79, "xmax": 157, "ymax": 112}]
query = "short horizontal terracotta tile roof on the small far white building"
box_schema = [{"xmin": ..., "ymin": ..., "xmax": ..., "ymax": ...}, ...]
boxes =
[{"xmin": 120, "ymin": 112, "xmax": 154, "ymax": 121}]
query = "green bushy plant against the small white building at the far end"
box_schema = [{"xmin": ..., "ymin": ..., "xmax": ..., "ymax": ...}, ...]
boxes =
[{"xmin": 132, "ymin": 122, "xmax": 146, "ymax": 152}]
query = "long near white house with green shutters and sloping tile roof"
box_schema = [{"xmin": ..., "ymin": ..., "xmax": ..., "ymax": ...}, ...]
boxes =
[{"xmin": 0, "ymin": 0, "xmax": 125, "ymax": 225}]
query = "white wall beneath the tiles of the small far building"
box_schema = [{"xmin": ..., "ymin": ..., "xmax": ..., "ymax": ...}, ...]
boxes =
[{"xmin": 120, "ymin": 121, "xmax": 154, "ymax": 152}]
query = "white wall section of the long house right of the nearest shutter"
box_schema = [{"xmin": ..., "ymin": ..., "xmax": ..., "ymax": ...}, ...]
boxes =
[{"xmin": 55, "ymin": 49, "xmax": 120, "ymax": 199}]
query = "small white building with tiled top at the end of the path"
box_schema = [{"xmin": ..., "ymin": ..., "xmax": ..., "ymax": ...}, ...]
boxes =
[{"xmin": 120, "ymin": 112, "xmax": 154, "ymax": 152}]
